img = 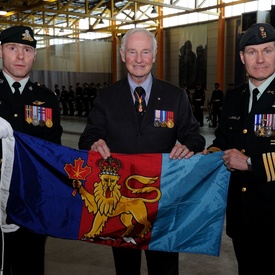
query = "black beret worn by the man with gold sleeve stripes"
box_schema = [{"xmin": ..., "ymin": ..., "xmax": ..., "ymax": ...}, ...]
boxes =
[{"xmin": 239, "ymin": 23, "xmax": 275, "ymax": 51}]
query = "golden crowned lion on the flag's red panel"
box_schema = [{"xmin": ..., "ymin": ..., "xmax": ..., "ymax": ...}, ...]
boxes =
[{"xmin": 73, "ymin": 158, "xmax": 161, "ymax": 239}]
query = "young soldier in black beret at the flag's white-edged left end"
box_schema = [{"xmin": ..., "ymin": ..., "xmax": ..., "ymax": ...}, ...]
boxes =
[{"xmin": 0, "ymin": 26, "xmax": 62, "ymax": 275}]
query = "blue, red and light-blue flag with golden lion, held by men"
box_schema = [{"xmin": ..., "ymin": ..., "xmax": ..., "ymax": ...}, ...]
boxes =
[{"xmin": 1, "ymin": 132, "xmax": 230, "ymax": 256}]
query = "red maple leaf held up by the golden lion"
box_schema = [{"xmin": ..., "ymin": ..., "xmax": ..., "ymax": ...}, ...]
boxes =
[{"xmin": 64, "ymin": 157, "xmax": 92, "ymax": 180}]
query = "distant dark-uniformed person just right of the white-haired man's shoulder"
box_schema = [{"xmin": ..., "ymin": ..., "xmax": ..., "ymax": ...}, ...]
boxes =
[{"xmin": 192, "ymin": 83, "xmax": 205, "ymax": 127}]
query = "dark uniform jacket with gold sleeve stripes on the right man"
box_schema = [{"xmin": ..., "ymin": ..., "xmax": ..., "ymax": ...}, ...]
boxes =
[{"xmin": 210, "ymin": 78, "xmax": 275, "ymax": 238}]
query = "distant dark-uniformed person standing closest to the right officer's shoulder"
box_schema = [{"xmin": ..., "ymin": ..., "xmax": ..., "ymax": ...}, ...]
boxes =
[{"xmin": 209, "ymin": 82, "xmax": 223, "ymax": 128}]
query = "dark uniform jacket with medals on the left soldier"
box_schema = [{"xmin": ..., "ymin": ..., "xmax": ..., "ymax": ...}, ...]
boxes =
[{"xmin": 0, "ymin": 72, "xmax": 62, "ymax": 147}]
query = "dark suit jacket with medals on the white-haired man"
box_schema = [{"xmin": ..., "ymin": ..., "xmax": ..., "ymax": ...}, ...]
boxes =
[{"xmin": 79, "ymin": 78, "xmax": 205, "ymax": 154}]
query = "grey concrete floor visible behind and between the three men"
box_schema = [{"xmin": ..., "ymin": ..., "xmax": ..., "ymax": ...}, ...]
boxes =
[{"xmin": 45, "ymin": 117, "xmax": 237, "ymax": 275}]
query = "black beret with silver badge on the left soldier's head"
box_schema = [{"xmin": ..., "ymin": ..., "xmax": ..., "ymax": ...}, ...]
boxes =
[{"xmin": 0, "ymin": 26, "xmax": 36, "ymax": 48}]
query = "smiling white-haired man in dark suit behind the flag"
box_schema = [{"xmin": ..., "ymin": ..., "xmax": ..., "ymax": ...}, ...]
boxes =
[{"xmin": 79, "ymin": 28, "xmax": 205, "ymax": 275}]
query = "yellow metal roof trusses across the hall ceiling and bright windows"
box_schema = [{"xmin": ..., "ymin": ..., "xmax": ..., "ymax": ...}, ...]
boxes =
[{"xmin": 0, "ymin": 0, "xmax": 256, "ymax": 42}]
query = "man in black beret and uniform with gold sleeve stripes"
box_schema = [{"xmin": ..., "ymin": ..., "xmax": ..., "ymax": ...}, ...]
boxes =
[{"xmin": 208, "ymin": 23, "xmax": 275, "ymax": 275}]
